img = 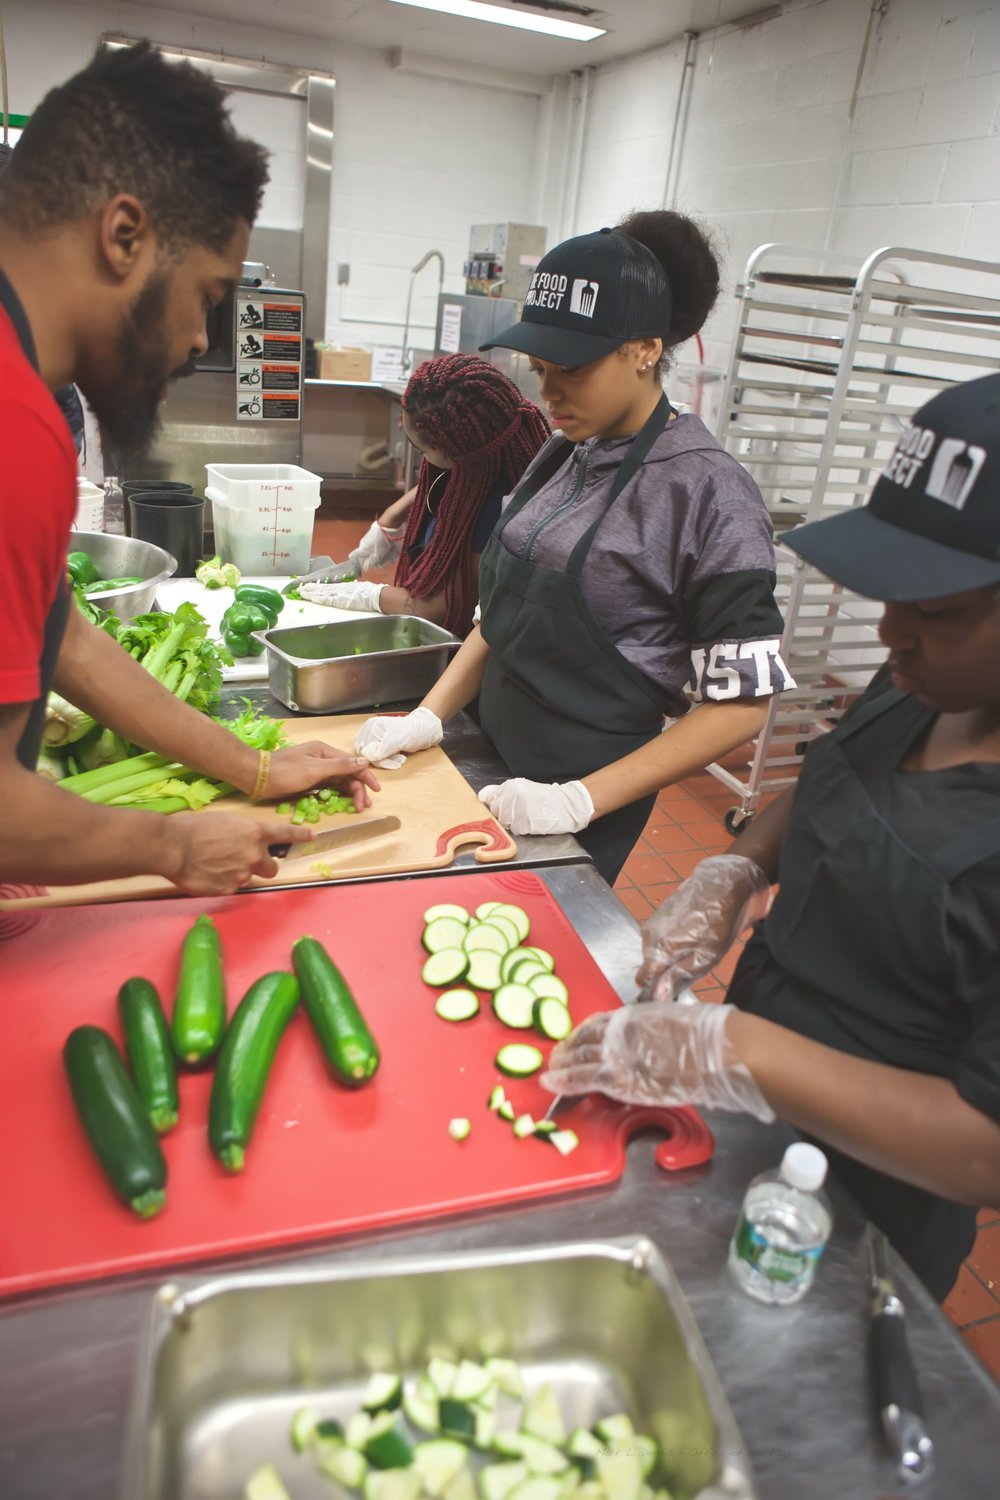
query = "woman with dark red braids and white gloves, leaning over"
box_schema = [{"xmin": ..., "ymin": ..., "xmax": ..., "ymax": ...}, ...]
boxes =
[{"xmin": 301, "ymin": 354, "xmax": 549, "ymax": 636}]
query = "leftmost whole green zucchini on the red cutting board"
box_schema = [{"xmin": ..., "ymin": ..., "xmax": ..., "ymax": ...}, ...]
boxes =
[{"xmin": 63, "ymin": 1026, "xmax": 166, "ymax": 1218}]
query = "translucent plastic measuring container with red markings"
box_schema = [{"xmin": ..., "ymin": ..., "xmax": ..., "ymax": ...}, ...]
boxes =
[{"xmin": 205, "ymin": 464, "xmax": 322, "ymax": 578}]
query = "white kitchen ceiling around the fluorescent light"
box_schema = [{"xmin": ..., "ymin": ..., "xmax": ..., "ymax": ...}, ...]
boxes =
[{"xmin": 115, "ymin": 0, "xmax": 771, "ymax": 75}]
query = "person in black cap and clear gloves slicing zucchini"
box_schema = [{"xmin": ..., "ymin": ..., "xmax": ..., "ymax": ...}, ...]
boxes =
[{"xmin": 543, "ymin": 375, "xmax": 1000, "ymax": 1299}]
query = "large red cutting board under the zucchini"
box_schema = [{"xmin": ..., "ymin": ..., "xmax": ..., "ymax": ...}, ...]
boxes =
[{"xmin": 0, "ymin": 872, "xmax": 712, "ymax": 1296}]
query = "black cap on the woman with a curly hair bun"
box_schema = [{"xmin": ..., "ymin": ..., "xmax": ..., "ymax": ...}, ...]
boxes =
[{"xmin": 480, "ymin": 230, "xmax": 672, "ymax": 366}]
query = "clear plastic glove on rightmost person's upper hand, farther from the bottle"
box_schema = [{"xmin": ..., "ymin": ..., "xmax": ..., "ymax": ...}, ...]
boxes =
[{"xmin": 636, "ymin": 854, "xmax": 771, "ymax": 1001}]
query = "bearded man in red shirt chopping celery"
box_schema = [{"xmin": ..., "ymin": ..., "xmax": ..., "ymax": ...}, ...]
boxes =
[{"xmin": 0, "ymin": 44, "xmax": 378, "ymax": 894}]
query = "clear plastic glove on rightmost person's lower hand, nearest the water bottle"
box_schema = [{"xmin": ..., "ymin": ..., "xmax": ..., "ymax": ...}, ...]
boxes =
[{"xmin": 541, "ymin": 1004, "xmax": 774, "ymax": 1122}]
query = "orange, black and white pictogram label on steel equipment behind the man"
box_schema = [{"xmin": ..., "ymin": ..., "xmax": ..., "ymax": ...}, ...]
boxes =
[{"xmin": 235, "ymin": 290, "xmax": 303, "ymax": 422}]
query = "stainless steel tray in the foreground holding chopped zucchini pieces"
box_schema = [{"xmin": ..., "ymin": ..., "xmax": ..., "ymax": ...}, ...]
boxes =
[{"xmin": 120, "ymin": 1236, "xmax": 756, "ymax": 1500}]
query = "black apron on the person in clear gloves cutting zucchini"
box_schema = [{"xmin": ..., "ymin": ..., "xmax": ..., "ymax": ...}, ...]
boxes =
[{"xmin": 727, "ymin": 689, "xmax": 1000, "ymax": 1301}]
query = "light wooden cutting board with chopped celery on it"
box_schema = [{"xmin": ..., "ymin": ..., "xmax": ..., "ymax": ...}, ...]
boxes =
[{"xmin": 0, "ymin": 714, "xmax": 517, "ymax": 912}]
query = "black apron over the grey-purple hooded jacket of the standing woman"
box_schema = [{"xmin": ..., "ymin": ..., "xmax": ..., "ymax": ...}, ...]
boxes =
[{"xmin": 478, "ymin": 396, "xmax": 672, "ymax": 885}]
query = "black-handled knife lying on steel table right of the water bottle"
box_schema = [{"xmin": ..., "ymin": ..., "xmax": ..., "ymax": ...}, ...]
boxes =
[{"xmin": 865, "ymin": 1224, "xmax": 934, "ymax": 1479}]
